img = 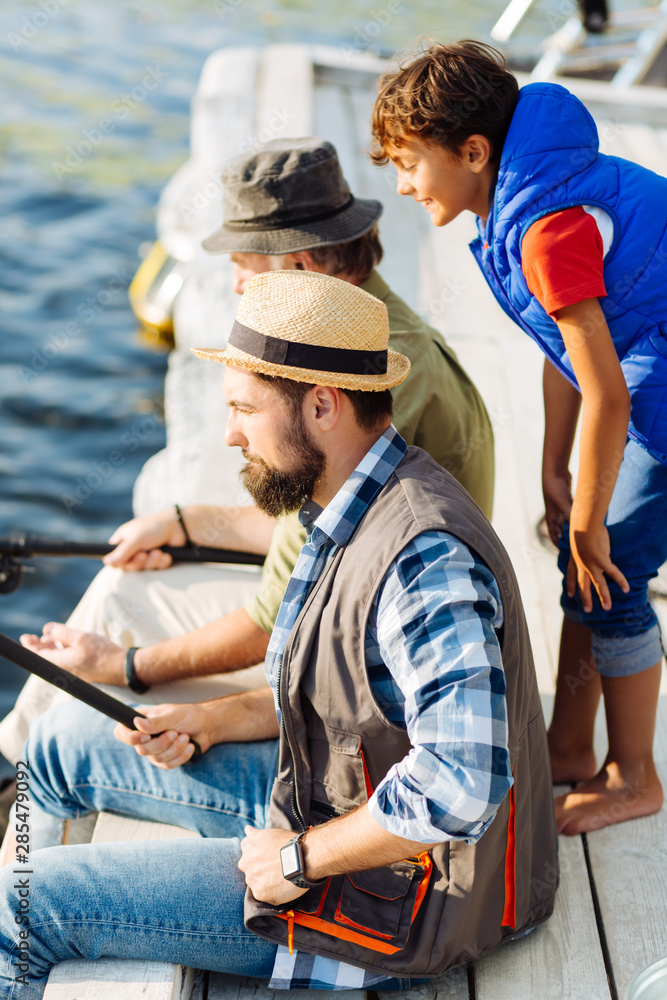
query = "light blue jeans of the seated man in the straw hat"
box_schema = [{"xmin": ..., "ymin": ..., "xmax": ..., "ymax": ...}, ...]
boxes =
[{"xmin": 0, "ymin": 702, "xmax": 277, "ymax": 1000}]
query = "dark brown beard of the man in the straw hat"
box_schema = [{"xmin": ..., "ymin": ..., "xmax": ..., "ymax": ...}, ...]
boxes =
[{"xmin": 240, "ymin": 412, "xmax": 326, "ymax": 517}]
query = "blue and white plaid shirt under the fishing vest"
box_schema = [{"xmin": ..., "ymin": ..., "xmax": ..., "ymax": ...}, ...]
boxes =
[{"xmin": 266, "ymin": 425, "xmax": 512, "ymax": 990}]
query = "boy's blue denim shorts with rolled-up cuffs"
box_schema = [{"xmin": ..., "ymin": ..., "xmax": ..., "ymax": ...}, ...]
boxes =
[{"xmin": 558, "ymin": 440, "xmax": 667, "ymax": 677}]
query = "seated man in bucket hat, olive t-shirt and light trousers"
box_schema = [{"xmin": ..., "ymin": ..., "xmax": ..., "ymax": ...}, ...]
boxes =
[{"xmin": 0, "ymin": 139, "xmax": 494, "ymax": 757}]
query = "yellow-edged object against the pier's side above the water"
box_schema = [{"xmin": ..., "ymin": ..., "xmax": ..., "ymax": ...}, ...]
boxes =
[{"xmin": 128, "ymin": 240, "xmax": 188, "ymax": 344}]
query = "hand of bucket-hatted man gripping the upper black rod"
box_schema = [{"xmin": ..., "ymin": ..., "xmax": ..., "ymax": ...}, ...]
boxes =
[{"xmin": 102, "ymin": 507, "xmax": 186, "ymax": 572}]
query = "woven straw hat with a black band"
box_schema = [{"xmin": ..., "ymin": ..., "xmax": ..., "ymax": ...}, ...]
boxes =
[{"xmin": 192, "ymin": 271, "xmax": 410, "ymax": 392}]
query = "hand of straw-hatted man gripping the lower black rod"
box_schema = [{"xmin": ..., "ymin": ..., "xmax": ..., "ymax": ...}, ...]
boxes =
[{"xmin": 114, "ymin": 703, "xmax": 211, "ymax": 770}]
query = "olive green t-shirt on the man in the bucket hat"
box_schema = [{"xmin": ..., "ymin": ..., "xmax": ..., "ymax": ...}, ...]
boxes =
[{"xmin": 246, "ymin": 272, "xmax": 494, "ymax": 632}]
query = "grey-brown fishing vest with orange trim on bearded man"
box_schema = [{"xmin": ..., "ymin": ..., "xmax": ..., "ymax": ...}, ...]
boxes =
[{"xmin": 245, "ymin": 448, "xmax": 558, "ymax": 976}]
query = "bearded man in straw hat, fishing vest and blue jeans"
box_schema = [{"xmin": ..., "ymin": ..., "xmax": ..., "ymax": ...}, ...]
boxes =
[{"xmin": 0, "ymin": 271, "xmax": 556, "ymax": 1000}]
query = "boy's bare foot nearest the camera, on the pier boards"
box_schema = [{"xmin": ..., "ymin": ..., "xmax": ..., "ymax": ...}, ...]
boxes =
[{"xmin": 554, "ymin": 762, "xmax": 664, "ymax": 836}]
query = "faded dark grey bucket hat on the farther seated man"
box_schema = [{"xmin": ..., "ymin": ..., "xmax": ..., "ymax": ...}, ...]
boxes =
[{"xmin": 202, "ymin": 138, "xmax": 382, "ymax": 254}]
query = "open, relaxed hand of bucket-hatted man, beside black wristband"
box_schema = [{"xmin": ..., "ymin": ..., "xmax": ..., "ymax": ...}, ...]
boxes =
[{"xmin": 21, "ymin": 622, "xmax": 125, "ymax": 687}]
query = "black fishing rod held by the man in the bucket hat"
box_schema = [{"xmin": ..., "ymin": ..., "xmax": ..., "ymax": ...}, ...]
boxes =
[{"xmin": 0, "ymin": 535, "xmax": 266, "ymax": 594}]
